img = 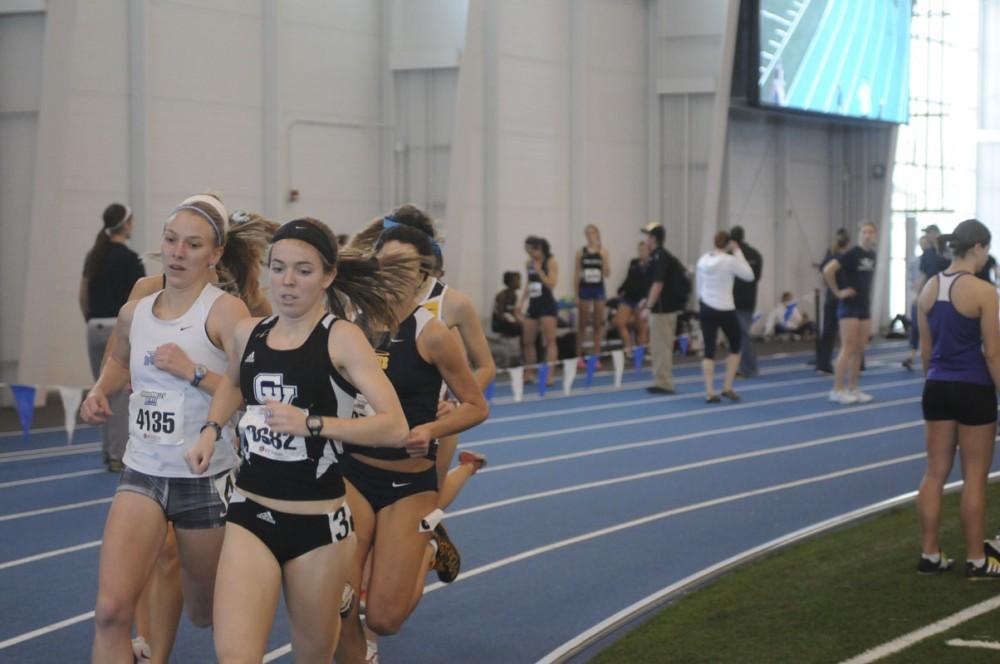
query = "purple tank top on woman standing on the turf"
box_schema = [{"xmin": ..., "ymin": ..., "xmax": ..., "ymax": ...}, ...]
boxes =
[{"xmin": 927, "ymin": 272, "xmax": 993, "ymax": 386}]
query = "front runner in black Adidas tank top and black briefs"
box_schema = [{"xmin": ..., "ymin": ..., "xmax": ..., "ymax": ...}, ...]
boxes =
[{"xmin": 191, "ymin": 219, "xmax": 407, "ymax": 661}]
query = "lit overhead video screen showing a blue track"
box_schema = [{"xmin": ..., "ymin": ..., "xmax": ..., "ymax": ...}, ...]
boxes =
[{"xmin": 758, "ymin": 0, "xmax": 911, "ymax": 123}]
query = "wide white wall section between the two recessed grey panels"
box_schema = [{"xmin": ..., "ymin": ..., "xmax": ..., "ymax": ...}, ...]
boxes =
[{"xmin": 446, "ymin": 0, "xmax": 648, "ymax": 306}]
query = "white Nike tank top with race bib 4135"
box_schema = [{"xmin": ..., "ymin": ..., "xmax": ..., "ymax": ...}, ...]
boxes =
[{"xmin": 123, "ymin": 284, "xmax": 238, "ymax": 477}]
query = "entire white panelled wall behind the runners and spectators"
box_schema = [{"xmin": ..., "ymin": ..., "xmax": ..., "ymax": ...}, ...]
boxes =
[{"xmin": 0, "ymin": 0, "xmax": 904, "ymax": 384}]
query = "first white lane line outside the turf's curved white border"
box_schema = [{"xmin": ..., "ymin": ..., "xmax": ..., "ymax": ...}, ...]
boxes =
[{"xmin": 263, "ymin": 452, "xmax": 925, "ymax": 662}]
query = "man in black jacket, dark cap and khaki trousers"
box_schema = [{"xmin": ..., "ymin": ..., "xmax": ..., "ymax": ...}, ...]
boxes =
[{"xmin": 642, "ymin": 221, "xmax": 691, "ymax": 394}]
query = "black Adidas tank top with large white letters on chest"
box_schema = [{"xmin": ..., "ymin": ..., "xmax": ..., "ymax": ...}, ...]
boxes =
[{"xmin": 236, "ymin": 314, "xmax": 358, "ymax": 500}]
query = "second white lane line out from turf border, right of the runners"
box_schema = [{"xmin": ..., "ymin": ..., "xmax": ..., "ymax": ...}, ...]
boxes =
[{"xmin": 448, "ymin": 420, "xmax": 924, "ymax": 519}]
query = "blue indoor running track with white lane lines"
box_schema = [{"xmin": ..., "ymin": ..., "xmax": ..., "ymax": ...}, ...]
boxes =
[{"xmin": 0, "ymin": 344, "xmax": 972, "ymax": 664}]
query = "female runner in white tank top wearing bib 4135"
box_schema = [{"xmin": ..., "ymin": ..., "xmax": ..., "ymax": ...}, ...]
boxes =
[{"xmin": 81, "ymin": 195, "xmax": 249, "ymax": 664}]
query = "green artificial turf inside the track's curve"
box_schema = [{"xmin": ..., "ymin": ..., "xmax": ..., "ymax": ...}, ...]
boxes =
[{"xmin": 593, "ymin": 484, "xmax": 1000, "ymax": 664}]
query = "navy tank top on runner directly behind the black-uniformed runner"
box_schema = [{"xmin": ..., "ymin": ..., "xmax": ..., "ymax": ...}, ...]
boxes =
[{"xmin": 344, "ymin": 306, "xmax": 441, "ymax": 461}]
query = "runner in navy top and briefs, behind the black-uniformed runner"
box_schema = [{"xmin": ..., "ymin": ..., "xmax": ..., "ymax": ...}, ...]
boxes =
[{"xmin": 337, "ymin": 226, "xmax": 488, "ymax": 662}]
